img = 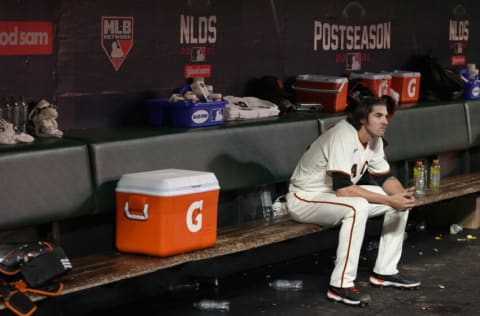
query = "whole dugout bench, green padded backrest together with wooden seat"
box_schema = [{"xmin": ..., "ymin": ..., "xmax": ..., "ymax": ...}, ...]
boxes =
[{"xmin": 0, "ymin": 101, "xmax": 480, "ymax": 312}]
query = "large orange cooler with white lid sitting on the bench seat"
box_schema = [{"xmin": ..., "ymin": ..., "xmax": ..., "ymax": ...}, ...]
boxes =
[{"xmin": 116, "ymin": 169, "xmax": 220, "ymax": 256}]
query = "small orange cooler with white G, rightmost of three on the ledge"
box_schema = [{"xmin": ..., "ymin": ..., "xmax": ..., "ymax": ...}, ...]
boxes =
[{"xmin": 391, "ymin": 70, "xmax": 421, "ymax": 103}]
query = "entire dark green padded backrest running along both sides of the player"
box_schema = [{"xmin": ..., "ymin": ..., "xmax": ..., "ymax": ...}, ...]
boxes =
[{"xmin": 0, "ymin": 100, "xmax": 480, "ymax": 229}]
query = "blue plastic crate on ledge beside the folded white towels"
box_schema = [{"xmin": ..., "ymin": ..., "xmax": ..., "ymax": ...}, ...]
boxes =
[{"xmin": 146, "ymin": 99, "xmax": 227, "ymax": 127}]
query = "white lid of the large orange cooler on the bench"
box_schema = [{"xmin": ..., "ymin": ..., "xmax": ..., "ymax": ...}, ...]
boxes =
[{"xmin": 115, "ymin": 169, "xmax": 220, "ymax": 196}]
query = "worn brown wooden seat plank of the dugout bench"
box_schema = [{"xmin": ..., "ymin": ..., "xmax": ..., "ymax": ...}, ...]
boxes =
[{"xmin": 5, "ymin": 172, "xmax": 480, "ymax": 309}]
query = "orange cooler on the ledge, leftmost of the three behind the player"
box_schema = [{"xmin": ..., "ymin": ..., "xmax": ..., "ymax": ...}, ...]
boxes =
[{"xmin": 293, "ymin": 75, "xmax": 348, "ymax": 112}]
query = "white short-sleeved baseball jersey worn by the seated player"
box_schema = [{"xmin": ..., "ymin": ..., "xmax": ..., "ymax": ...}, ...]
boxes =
[{"xmin": 290, "ymin": 120, "xmax": 390, "ymax": 193}]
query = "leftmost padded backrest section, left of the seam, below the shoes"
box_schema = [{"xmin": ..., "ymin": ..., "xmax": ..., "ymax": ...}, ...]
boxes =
[{"xmin": 0, "ymin": 139, "xmax": 94, "ymax": 229}]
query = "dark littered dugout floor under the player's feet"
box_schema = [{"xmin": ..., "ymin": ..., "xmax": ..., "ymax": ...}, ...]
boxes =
[{"xmin": 42, "ymin": 220, "xmax": 480, "ymax": 316}]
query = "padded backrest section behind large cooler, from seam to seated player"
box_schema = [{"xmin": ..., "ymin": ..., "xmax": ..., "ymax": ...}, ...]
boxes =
[{"xmin": 63, "ymin": 118, "xmax": 319, "ymax": 212}]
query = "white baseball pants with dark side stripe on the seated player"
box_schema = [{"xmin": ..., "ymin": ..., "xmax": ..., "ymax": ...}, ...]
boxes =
[{"xmin": 287, "ymin": 185, "xmax": 409, "ymax": 288}]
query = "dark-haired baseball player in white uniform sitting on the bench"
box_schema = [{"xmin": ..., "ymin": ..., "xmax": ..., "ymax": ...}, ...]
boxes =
[{"xmin": 287, "ymin": 97, "xmax": 420, "ymax": 306}]
